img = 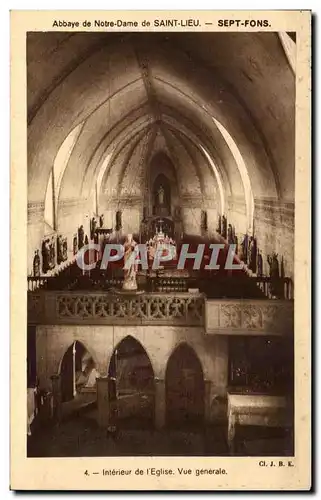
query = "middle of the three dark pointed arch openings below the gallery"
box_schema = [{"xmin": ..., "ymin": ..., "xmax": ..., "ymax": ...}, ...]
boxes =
[{"xmin": 108, "ymin": 336, "xmax": 155, "ymax": 428}]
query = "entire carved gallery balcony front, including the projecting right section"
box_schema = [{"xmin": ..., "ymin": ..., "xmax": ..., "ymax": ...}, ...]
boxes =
[{"xmin": 28, "ymin": 290, "xmax": 294, "ymax": 336}]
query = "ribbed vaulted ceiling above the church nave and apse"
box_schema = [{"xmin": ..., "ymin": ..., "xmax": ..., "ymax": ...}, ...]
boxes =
[{"xmin": 27, "ymin": 32, "xmax": 295, "ymax": 207}]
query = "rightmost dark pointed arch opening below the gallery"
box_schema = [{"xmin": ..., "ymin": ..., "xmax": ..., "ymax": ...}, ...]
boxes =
[{"xmin": 165, "ymin": 343, "xmax": 204, "ymax": 427}]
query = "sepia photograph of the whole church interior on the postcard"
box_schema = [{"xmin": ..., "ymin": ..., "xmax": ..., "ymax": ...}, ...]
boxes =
[{"xmin": 26, "ymin": 32, "xmax": 296, "ymax": 457}]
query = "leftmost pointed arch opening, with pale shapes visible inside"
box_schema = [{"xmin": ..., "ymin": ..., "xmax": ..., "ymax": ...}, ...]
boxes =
[{"xmin": 60, "ymin": 340, "xmax": 99, "ymax": 403}]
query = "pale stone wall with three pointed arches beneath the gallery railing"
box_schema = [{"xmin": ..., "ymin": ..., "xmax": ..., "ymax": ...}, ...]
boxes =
[{"xmin": 36, "ymin": 325, "xmax": 228, "ymax": 420}]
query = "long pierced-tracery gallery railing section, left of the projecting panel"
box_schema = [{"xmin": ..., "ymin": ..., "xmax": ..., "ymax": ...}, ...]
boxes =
[{"xmin": 28, "ymin": 291, "xmax": 204, "ymax": 326}]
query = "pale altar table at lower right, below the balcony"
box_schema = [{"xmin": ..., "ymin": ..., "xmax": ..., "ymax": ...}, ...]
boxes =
[{"xmin": 227, "ymin": 394, "xmax": 291, "ymax": 453}]
